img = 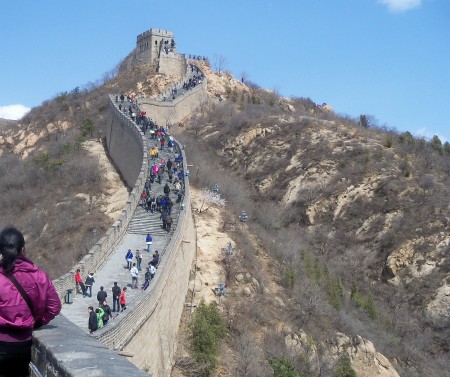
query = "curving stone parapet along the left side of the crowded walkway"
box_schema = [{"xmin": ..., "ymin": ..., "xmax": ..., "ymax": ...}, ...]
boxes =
[{"xmin": 49, "ymin": 98, "xmax": 148, "ymax": 299}]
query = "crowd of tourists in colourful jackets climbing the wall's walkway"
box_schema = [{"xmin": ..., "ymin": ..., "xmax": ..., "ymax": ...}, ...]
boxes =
[{"xmin": 79, "ymin": 94, "xmax": 186, "ymax": 333}]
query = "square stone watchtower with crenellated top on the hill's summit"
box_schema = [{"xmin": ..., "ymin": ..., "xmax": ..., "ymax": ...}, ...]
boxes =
[{"xmin": 136, "ymin": 28, "xmax": 176, "ymax": 66}]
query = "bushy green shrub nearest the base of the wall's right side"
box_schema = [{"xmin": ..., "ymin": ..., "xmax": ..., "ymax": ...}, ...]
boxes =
[{"xmin": 188, "ymin": 300, "xmax": 227, "ymax": 377}]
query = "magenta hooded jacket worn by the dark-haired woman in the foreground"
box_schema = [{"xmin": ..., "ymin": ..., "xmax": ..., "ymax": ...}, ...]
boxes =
[{"xmin": 0, "ymin": 256, "xmax": 61, "ymax": 342}]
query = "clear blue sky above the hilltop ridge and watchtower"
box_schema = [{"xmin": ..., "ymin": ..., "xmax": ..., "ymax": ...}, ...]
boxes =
[{"xmin": 0, "ymin": 0, "xmax": 450, "ymax": 140}]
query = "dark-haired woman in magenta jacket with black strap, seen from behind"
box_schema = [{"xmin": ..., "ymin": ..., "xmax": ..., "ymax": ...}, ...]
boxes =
[{"xmin": 0, "ymin": 227, "xmax": 61, "ymax": 377}]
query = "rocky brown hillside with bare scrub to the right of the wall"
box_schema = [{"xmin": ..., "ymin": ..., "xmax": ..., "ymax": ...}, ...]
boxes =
[{"xmin": 172, "ymin": 63, "xmax": 450, "ymax": 376}]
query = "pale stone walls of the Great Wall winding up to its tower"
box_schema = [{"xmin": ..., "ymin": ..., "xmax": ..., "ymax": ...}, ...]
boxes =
[{"xmin": 30, "ymin": 29, "xmax": 206, "ymax": 377}]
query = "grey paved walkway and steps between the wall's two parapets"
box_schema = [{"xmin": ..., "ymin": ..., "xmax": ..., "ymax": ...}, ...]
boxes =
[{"xmin": 61, "ymin": 107, "xmax": 180, "ymax": 332}]
